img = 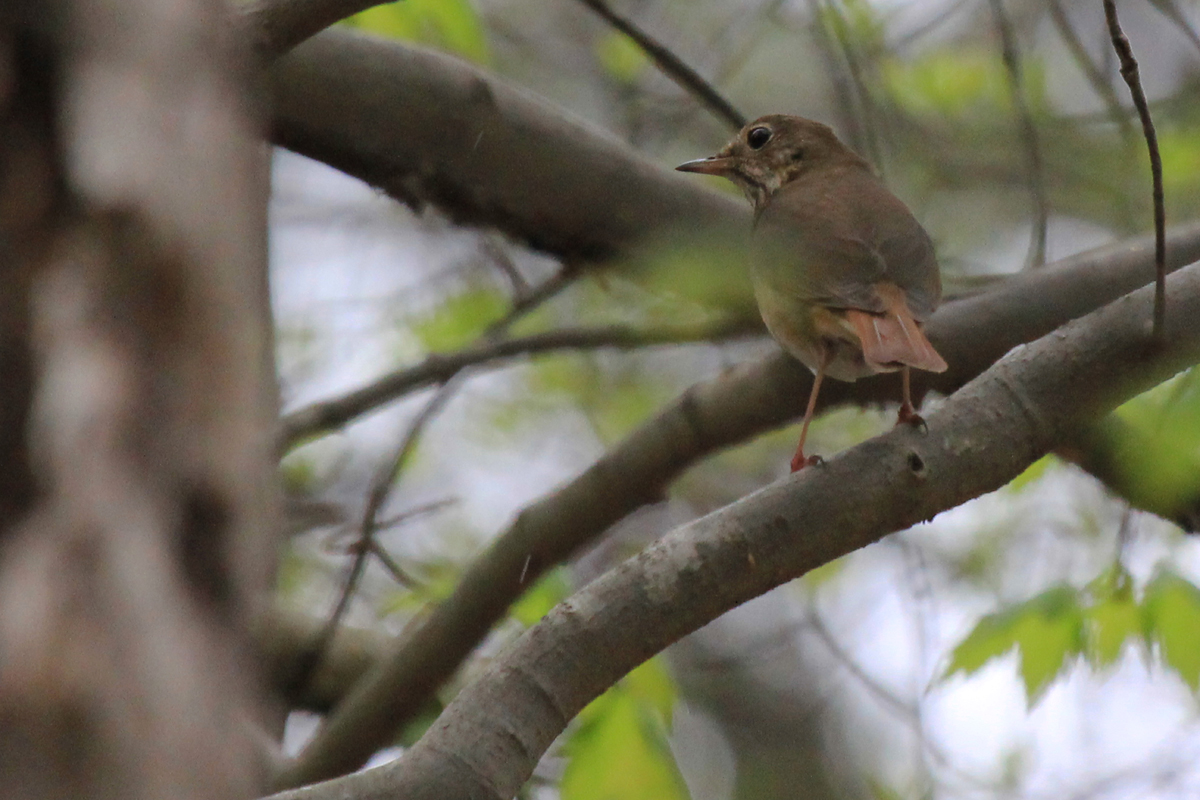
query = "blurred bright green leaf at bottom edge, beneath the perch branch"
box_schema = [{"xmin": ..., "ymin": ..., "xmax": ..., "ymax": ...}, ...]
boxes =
[{"xmin": 559, "ymin": 658, "xmax": 689, "ymax": 800}]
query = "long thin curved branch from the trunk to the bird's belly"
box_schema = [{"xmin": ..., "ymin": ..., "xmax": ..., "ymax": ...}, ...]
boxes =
[{"xmin": 280, "ymin": 319, "xmax": 758, "ymax": 451}]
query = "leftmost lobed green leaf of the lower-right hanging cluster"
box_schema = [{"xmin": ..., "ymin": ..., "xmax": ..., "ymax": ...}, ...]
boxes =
[{"xmin": 944, "ymin": 587, "xmax": 1084, "ymax": 704}]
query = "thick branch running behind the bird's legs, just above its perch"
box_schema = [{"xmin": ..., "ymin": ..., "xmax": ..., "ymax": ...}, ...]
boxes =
[{"xmin": 277, "ymin": 225, "xmax": 1200, "ymax": 787}]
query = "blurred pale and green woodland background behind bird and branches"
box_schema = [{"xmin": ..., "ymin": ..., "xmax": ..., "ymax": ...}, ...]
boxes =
[{"xmin": 271, "ymin": 0, "xmax": 1200, "ymax": 800}]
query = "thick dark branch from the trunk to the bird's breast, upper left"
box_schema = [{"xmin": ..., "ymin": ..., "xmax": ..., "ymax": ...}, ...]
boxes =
[{"xmin": 270, "ymin": 30, "xmax": 750, "ymax": 263}]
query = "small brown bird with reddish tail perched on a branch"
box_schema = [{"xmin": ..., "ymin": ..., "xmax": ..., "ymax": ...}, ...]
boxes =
[{"xmin": 676, "ymin": 114, "xmax": 947, "ymax": 473}]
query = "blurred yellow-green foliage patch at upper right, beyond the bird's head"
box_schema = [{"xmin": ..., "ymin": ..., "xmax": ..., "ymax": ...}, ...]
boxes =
[{"xmin": 882, "ymin": 46, "xmax": 1045, "ymax": 122}]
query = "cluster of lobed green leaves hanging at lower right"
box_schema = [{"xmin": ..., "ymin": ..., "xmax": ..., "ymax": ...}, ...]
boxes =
[{"xmin": 943, "ymin": 565, "xmax": 1200, "ymax": 704}]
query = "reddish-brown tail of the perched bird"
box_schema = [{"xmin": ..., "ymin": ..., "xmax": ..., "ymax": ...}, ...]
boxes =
[{"xmin": 846, "ymin": 283, "xmax": 947, "ymax": 372}]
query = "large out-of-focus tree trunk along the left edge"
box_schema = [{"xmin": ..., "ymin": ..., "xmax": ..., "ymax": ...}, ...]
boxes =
[{"xmin": 0, "ymin": 0, "xmax": 276, "ymax": 799}]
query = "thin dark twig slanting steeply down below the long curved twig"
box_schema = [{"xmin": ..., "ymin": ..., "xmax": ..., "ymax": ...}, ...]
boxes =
[{"xmin": 286, "ymin": 380, "xmax": 460, "ymax": 697}]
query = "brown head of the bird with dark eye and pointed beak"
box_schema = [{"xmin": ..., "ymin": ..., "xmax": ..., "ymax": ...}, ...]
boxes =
[{"xmin": 676, "ymin": 114, "xmax": 866, "ymax": 211}]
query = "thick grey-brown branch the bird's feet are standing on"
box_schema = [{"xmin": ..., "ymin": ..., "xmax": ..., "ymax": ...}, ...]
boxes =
[{"xmin": 276, "ymin": 260, "xmax": 1200, "ymax": 800}]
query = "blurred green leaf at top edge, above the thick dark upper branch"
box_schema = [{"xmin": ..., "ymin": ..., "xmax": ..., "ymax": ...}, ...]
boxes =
[{"xmin": 347, "ymin": 0, "xmax": 492, "ymax": 64}]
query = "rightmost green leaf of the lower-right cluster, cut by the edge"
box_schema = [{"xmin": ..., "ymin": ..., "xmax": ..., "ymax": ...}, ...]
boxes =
[{"xmin": 1142, "ymin": 570, "xmax": 1200, "ymax": 691}]
